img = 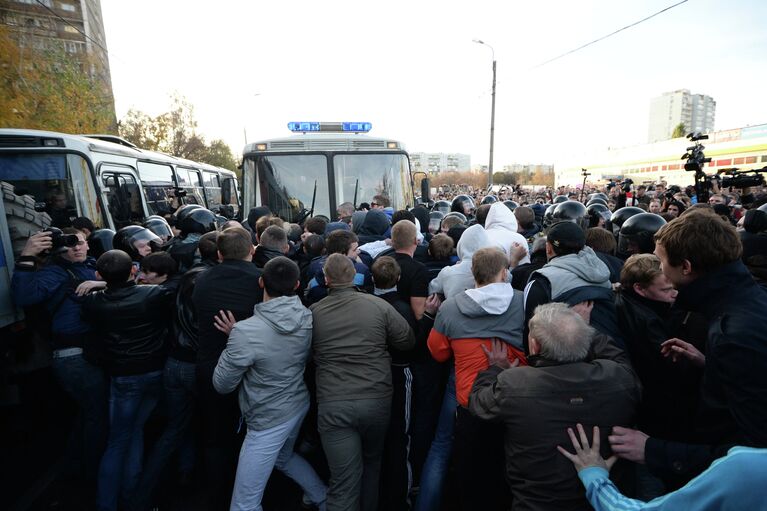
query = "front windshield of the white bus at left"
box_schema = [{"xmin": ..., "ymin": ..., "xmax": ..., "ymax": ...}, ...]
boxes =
[{"xmin": 0, "ymin": 154, "xmax": 82, "ymax": 228}]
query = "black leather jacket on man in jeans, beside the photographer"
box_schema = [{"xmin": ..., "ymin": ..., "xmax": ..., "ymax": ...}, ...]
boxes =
[{"xmin": 82, "ymin": 282, "xmax": 173, "ymax": 376}]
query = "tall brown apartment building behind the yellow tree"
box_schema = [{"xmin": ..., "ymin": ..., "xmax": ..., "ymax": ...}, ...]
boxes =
[{"xmin": 0, "ymin": 0, "xmax": 114, "ymax": 121}]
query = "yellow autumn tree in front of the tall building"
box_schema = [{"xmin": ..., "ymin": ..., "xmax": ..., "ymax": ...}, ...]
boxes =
[{"xmin": 0, "ymin": 25, "xmax": 115, "ymax": 133}]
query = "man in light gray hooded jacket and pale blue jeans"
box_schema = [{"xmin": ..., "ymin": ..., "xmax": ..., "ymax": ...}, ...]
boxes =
[{"xmin": 213, "ymin": 256, "xmax": 326, "ymax": 511}]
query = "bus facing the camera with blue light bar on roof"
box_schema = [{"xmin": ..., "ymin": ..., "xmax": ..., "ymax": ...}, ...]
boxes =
[{"xmin": 242, "ymin": 122, "xmax": 414, "ymax": 223}]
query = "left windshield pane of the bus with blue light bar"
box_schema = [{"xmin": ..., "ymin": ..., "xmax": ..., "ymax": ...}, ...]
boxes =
[{"xmin": 257, "ymin": 154, "xmax": 332, "ymax": 222}]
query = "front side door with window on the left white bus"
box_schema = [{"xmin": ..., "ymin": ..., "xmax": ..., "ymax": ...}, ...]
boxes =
[{"xmin": 99, "ymin": 164, "xmax": 147, "ymax": 230}]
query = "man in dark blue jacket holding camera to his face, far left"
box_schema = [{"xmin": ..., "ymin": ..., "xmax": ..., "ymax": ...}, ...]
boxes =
[{"xmin": 11, "ymin": 228, "xmax": 107, "ymax": 496}]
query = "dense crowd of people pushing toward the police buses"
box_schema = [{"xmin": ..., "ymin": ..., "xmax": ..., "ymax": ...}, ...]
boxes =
[{"xmin": 12, "ymin": 182, "xmax": 767, "ymax": 511}]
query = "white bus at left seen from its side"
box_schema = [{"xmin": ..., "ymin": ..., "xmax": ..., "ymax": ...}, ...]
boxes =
[{"xmin": 0, "ymin": 129, "xmax": 240, "ymax": 333}]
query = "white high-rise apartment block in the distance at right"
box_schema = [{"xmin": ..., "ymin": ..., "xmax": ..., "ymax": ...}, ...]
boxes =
[{"xmin": 647, "ymin": 89, "xmax": 716, "ymax": 143}]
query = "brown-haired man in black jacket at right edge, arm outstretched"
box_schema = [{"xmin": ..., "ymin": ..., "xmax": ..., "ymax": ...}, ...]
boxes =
[{"xmin": 609, "ymin": 208, "xmax": 767, "ymax": 488}]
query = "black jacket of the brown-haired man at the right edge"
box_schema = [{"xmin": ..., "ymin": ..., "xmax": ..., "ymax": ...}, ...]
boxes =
[{"xmin": 645, "ymin": 261, "xmax": 767, "ymax": 477}]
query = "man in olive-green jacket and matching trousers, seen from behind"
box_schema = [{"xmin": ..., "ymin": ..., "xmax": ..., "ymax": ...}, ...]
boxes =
[{"xmin": 311, "ymin": 254, "xmax": 415, "ymax": 511}]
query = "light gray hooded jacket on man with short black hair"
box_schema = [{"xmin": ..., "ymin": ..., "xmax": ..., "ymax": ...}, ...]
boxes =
[{"xmin": 213, "ymin": 296, "xmax": 312, "ymax": 430}]
